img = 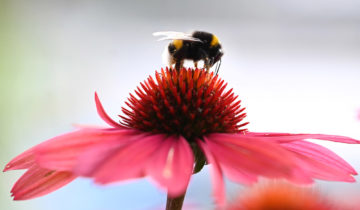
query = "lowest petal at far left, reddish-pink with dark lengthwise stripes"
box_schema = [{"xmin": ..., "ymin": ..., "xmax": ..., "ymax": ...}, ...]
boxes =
[{"xmin": 11, "ymin": 166, "xmax": 76, "ymax": 200}]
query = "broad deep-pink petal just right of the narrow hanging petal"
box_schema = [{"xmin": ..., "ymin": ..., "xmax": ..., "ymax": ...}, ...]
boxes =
[{"xmin": 206, "ymin": 134, "xmax": 296, "ymax": 178}]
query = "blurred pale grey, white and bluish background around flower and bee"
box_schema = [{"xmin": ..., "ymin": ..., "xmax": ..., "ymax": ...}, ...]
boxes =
[{"xmin": 0, "ymin": 0, "xmax": 360, "ymax": 210}]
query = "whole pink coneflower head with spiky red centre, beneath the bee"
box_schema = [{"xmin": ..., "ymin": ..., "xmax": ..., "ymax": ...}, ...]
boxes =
[{"xmin": 4, "ymin": 69, "xmax": 359, "ymax": 205}]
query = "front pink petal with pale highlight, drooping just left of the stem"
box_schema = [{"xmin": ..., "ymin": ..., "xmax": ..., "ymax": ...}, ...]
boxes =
[{"xmin": 147, "ymin": 136, "xmax": 194, "ymax": 197}]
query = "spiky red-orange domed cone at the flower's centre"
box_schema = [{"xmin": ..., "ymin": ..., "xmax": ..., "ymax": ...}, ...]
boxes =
[{"xmin": 120, "ymin": 68, "xmax": 248, "ymax": 141}]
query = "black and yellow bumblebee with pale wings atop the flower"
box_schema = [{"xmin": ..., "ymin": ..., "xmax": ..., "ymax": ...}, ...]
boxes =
[{"xmin": 153, "ymin": 31, "xmax": 224, "ymax": 74}]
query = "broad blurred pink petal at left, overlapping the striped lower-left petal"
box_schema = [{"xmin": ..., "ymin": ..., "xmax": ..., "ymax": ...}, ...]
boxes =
[{"xmin": 34, "ymin": 129, "xmax": 134, "ymax": 171}]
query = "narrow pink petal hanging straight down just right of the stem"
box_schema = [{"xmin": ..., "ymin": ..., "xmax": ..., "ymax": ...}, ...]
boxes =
[{"xmin": 197, "ymin": 137, "xmax": 226, "ymax": 209}]
